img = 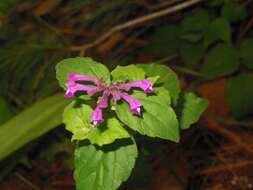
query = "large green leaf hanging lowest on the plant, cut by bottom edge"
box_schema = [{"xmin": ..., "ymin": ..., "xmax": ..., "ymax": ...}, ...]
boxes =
[{"xmin": 74, "ymin": 139, "xmax": 138, "ymax": 190}]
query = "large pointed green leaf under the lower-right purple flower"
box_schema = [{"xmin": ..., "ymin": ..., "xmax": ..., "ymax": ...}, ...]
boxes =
[{"xmin": 116, "ymin": 89, "xmax": 179, "ymax": 142}]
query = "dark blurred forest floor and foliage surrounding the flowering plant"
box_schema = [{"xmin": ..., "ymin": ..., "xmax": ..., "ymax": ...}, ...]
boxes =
[{"xmin": 0, "ymin": 0, "xmax": 253, "ymax": 190}]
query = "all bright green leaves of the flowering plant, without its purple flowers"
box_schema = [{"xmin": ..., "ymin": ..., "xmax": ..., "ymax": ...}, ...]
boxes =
[{"xmin": 56, "ymin": 58, "xmax": 207, "ymax": 190}]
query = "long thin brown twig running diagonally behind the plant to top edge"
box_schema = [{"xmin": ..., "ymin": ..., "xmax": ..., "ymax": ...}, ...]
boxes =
[{"xmin": 70, "ymin": 0, "xmax": 204, "ymax": 56}]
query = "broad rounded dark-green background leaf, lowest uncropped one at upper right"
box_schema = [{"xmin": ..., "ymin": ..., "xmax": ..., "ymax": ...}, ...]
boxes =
[{"xmin": 201, "ymin": 44, "xmax": 239, "ymax": 79}]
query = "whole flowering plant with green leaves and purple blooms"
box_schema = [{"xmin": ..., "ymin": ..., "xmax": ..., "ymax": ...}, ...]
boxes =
[{"xmin": 56, "ymin": 57, "xmax": 208, "ymax": 190}]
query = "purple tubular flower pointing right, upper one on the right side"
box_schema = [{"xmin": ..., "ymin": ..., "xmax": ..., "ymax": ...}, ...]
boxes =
[{"xmin": 122, "ymin": 79, "xmax": 154, "ymax": 93}]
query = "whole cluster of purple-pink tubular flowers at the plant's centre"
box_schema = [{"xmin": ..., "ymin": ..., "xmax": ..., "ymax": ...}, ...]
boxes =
[{"xmin": 65, "ymin": 73, "xmax": 154, "ymax": 126}]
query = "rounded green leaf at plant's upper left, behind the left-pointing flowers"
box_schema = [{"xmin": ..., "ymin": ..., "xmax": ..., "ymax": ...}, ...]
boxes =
[{"xmin": 56, "ymin": 57, "xmax": 110, "ymax": 89}]
